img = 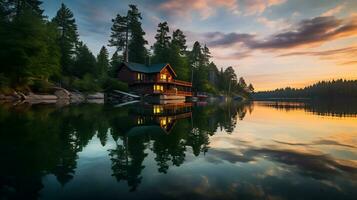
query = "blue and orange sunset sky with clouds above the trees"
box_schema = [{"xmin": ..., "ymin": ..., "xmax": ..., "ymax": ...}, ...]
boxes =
[{"xmin": 43, "ymin": 0, "xmax": 357, "ymax": 91}]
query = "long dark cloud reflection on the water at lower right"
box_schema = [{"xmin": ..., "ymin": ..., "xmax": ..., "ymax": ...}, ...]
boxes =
[{"xmin": 206, "ymin": 147, "xmax": 357, "ymax": 180}]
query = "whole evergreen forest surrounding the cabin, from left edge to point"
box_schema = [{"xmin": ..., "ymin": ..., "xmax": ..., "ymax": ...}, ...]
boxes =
[{"xmin": 0, "ymin": 0, "xmax": 254, "ymax": 96}]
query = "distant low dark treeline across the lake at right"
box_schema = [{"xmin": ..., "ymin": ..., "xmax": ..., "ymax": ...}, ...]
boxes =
[{"xmin": 253, "ymin": 79, "xmax": 357, "ymax": 99}]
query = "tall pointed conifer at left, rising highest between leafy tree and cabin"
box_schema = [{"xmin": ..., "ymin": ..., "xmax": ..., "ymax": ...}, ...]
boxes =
[{"xmin": 52, "ymin": 4, "xmax": 78, "ymax": 75}]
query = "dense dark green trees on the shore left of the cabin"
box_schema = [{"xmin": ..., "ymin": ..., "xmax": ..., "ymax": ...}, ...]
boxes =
[{"xmin": 0, "ymin": 0, "xmax": 127, "ymax": 93}]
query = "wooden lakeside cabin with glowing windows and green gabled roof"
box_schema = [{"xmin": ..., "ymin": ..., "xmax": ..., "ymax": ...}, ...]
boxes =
[{"xmin": 118, "ymin": 63, "xmax": 192, "ymax": 99}]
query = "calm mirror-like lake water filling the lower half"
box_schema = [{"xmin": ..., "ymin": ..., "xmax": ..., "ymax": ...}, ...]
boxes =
[{"xmin": 0, "ymin": 102, "xmax": 357, "ymax": 200}]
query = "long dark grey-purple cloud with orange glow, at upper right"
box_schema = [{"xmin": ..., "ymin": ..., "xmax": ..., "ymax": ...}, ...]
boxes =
[{"xmin": 205, "ymin": 16, "xmax": 357, "ymax": 50}]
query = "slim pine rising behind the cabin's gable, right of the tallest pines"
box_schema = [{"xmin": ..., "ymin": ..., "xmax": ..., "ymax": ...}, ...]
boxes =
[{"xmin": 153, "ymin": 22, "xmax": 171, "ymax": 63}]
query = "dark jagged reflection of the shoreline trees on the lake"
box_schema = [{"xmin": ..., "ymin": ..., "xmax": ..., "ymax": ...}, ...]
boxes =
[{"xmin": 0, "ymin": 100, "xmax": 253, "ymax": 195}]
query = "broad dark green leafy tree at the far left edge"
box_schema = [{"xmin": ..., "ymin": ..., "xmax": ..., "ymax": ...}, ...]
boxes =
[{"xmin": 0, "ymin": 5, "xmax": 60, "ymax": 85}]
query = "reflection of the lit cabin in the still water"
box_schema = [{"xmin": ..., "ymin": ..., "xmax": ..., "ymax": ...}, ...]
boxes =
[{"xmin": 127, "ymin": 103, "xmax": 192, "ymax": 136}]
